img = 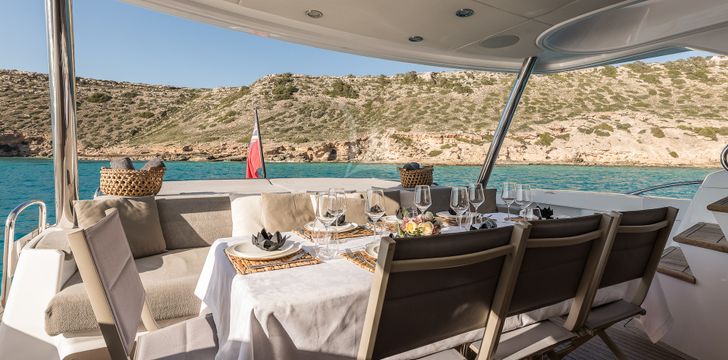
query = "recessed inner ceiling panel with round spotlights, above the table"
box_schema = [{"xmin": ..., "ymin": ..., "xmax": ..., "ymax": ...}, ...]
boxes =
[{"xmin": 225, "ymin": 0, "xmax": 528, "ymax": 51}]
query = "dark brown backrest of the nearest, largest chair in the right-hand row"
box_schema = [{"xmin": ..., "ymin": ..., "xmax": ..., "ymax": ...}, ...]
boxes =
[{"xmin": 358, "ymin": 225, "xmax": 528, "ymax": 359}]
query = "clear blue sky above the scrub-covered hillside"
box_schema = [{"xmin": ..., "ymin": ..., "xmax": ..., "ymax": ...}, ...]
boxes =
[{"xmin": 0, "ymin": 0, "xmax": 707, "ymax": 87}]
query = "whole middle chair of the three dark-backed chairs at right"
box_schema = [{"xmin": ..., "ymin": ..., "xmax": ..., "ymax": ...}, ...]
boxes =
[{"xmin": 469, "ymin": 214, "xmax": 617, "ymax": 359}]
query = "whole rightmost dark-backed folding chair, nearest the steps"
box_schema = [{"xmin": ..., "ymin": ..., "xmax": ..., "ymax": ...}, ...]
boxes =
[{"xmin": 552, "ymin": 207, "xmax": 678, "ymax": 359}]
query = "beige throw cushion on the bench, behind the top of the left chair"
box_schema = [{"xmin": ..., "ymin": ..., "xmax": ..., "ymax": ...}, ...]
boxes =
[{"xmin": 74, "ymin": 196, "xmax": 167, "ymax": 259}]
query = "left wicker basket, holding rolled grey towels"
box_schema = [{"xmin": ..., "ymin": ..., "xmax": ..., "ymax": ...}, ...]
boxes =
[{"xmin": 101, "ymin": 168, "xmax": 164, "ymax": 196}]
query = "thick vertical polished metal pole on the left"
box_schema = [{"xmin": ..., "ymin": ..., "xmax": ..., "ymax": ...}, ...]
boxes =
[{"xmin": 45, "ymin": 0, "xmax": 78, "ymax": 227}]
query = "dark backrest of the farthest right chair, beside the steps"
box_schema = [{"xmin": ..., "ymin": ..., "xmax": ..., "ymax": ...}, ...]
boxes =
[{"xmin": 598, "ymin": 207, "xmax": 678, "ymax": 305}]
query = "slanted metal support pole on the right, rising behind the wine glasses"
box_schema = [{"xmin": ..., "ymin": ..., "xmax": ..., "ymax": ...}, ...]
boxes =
[{"xmin": 478, "ymin": 56, "xmax": 537, "ymax": 188}]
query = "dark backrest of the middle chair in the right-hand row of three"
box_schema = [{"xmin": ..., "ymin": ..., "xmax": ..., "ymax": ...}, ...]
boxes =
[{"xmin": 508, "ymin": 214, "xmax": 617, "ymax": 330}]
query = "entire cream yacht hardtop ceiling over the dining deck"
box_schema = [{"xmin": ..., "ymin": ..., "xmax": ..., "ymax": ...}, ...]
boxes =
[{"xmin": 126, "ymin": 0, "xmax": 728, "ymax": 73}]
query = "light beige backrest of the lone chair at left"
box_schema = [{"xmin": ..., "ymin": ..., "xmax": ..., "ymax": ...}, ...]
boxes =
[{"xmin": 68, "ymin": 209, "xmax": 156, "ymax": 359}]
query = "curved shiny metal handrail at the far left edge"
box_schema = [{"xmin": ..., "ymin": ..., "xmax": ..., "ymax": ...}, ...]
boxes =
[{"xmin": 0, "ymin": 200, "xmax": 48, "ymax": 308}]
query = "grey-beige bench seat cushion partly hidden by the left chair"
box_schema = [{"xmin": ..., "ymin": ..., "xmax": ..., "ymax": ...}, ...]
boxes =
[{"xmin": 45, "ymin": 247, "xmax": 210, "ymax": 336}]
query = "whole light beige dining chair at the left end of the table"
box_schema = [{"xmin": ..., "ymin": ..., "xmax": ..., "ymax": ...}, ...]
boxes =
[{"xmin": 68, "ymin": 209, "xmax": 218, "ymax": 360}]
